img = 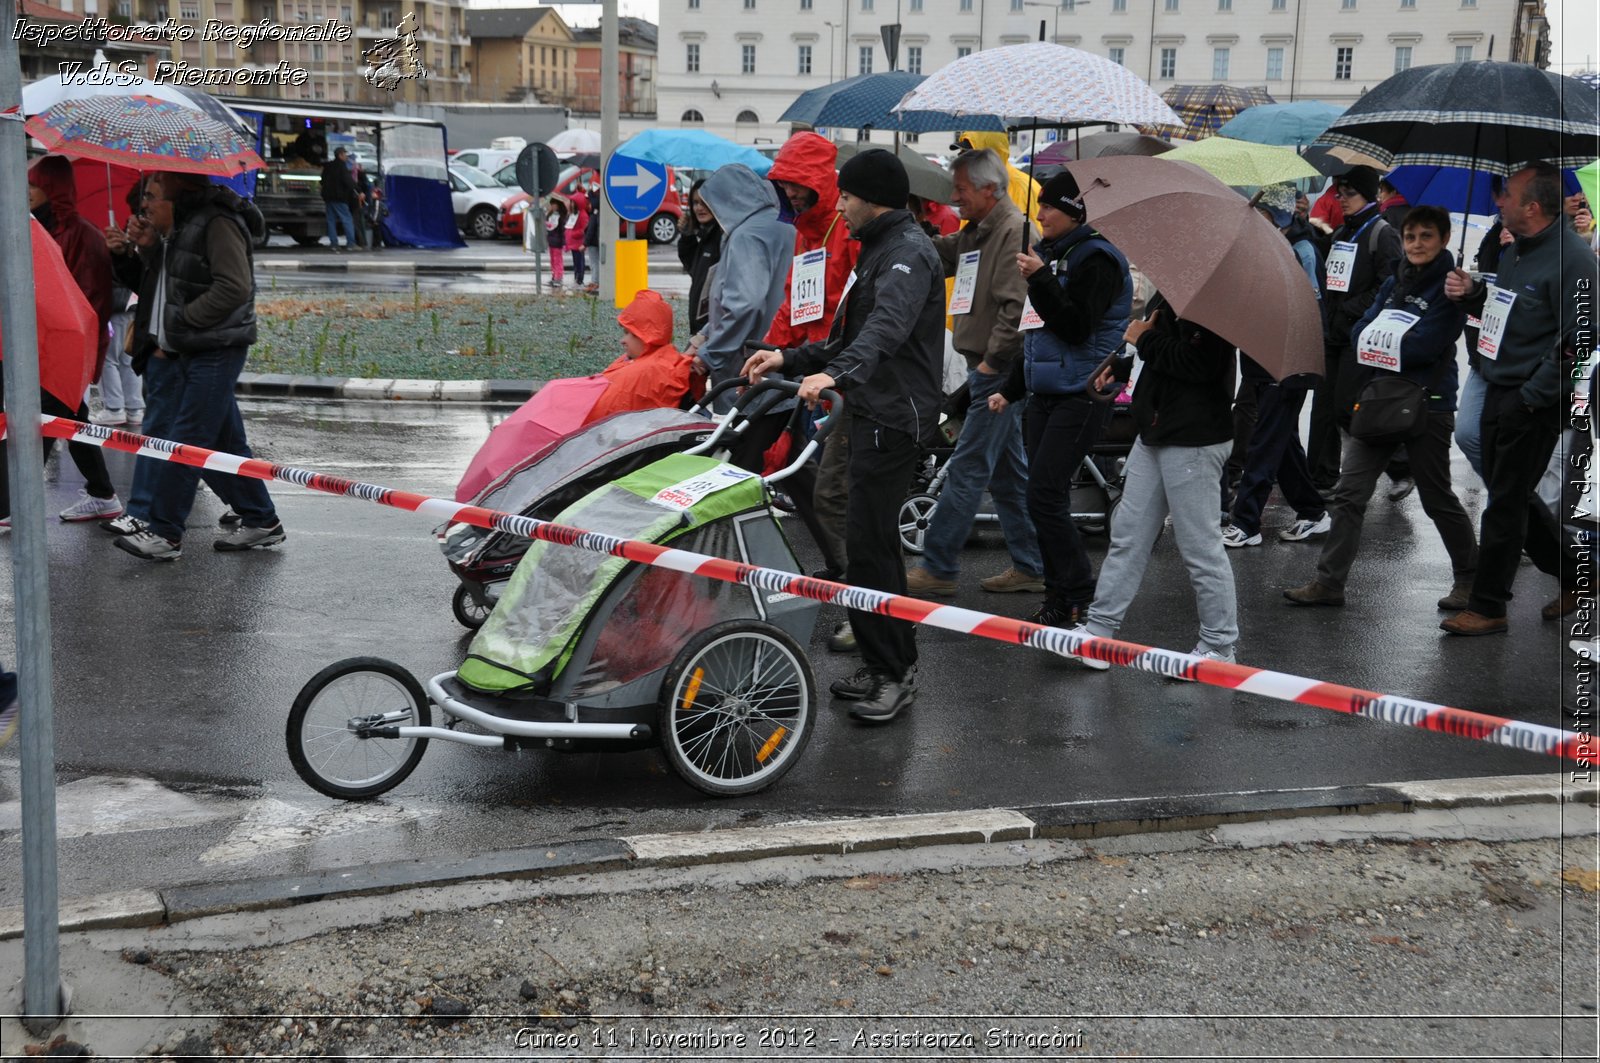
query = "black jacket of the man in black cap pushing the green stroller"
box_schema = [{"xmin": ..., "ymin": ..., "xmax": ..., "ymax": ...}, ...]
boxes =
[{"xmin": 784, "ymin": 210, "xmax": 944, "ymax": 439}]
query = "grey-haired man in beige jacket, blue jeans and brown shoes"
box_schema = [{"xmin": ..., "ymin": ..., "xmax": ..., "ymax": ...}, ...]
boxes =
[{"xmin": 906, "ymin": 150, "xmax": 1045, "ymax": 597}]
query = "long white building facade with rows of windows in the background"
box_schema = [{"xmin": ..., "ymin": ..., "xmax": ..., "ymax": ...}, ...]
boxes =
[{"xmin": 658, "ymin": 0, "xmax": 1549, "ymax": 144}]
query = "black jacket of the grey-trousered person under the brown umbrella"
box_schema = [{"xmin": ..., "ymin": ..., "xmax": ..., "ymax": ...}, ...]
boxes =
[{"xmin": 1115, "ymin": 295, "xmax": 1234, "ymax": 447}]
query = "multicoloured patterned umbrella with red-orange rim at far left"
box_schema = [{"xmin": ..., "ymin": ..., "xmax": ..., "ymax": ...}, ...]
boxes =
[{"xmin": 27, "ymin": 96, "xmax": 266, "ymax": 178}]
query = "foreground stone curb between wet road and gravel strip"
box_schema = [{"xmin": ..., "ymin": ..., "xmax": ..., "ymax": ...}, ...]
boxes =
[{"xmin": 0, "ymin": 775, "xmax": 1600, "ymax": 941}]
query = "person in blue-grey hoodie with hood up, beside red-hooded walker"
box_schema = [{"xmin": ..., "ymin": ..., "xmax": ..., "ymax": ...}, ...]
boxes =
[{"xmin": 694, "ymin": 163, "xmax": 795, "ymax": 416}]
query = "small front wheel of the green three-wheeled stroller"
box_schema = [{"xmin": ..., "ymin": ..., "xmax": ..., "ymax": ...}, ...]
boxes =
[{"xmin": 286, "ymin": 656, "xmax": 432, "ymax": 800}]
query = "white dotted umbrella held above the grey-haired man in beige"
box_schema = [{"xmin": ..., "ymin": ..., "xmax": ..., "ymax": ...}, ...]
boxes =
[{"xmin": 894, "ymin": 42, "xmax": 1181, "ymax": 125}]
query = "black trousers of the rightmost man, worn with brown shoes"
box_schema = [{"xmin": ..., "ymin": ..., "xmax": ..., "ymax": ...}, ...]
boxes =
[{"xmin": 1467, "ymin": 384, "xmax": 1566, "ymax": 618}]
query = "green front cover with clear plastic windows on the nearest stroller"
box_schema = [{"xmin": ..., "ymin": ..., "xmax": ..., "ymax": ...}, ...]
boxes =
[{"xmin": 456, "ymin": 455, "xmax": 765, "ymax": 693}]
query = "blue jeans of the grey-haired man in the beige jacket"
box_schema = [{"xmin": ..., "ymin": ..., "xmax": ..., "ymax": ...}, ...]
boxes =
[{"xmin": 923, "ymin": 370, "xmax": 1045, "ymax": 580}]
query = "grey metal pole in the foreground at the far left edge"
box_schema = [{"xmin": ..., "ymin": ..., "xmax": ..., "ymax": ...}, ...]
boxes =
[{"xmin": 0, "ymin": 0, "xmax": 67, "ymax": 1036}]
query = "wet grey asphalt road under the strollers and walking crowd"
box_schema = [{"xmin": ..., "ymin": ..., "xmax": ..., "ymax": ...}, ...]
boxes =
[{"xmin": 0, "ymin": 400, "xmax": 1565, "ymax": 905}]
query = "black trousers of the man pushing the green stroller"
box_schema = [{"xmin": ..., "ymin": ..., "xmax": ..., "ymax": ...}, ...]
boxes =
[{"xmin": 845, "ymin": 416, "xmax": 918, "ymax": 680}]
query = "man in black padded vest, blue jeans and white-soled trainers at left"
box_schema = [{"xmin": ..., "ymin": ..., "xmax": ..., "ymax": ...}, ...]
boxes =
[{"xmin": 115, "ymin": 173, "xmax": 285, "ymax": 560}]
